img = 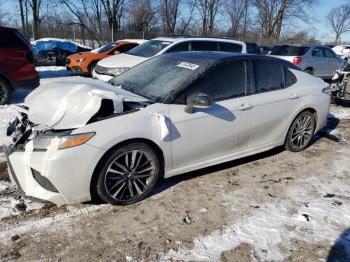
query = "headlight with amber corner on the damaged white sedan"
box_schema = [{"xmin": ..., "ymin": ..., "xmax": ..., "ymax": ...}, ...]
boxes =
[{"xmin": 33, "ymin": 132, "xmax": 96, "ymax": 150}]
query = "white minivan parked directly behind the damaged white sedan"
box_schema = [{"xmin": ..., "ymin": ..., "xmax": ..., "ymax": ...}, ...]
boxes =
[{"xmin": 93, "ymin": 36, "xmax": 248, "ymax": 81}]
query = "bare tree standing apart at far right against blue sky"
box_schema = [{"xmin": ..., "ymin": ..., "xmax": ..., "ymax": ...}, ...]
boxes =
[{"xmin": 326, "ymin": 4, "xmax": 350, "ymax": 44}]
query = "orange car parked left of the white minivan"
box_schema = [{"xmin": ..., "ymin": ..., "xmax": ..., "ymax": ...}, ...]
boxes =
[{"xmin": 66, "ymin": 39, "xmax": 147, "ymax": 75}]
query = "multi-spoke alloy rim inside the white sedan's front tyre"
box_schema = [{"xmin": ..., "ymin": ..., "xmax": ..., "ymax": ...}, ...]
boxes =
[{"xmin": 104, "ymin": 150, "xmax": 155, "ymax": 201}]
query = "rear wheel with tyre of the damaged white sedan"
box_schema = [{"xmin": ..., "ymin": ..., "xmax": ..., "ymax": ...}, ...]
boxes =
[{"xmin": 285, "ymin": 111, "xmax": 316, "ymax": 152}]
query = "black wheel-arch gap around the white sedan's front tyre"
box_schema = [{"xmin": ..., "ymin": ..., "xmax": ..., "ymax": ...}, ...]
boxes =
[{"xmin": 90, "ymin": 138, "xmax": 165, "ymax": 200}]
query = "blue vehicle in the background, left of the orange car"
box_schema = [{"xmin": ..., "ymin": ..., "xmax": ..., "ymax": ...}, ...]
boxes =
[{"xmin": 32, "ymin": 38, "xmax": 92, "ymax": 66}]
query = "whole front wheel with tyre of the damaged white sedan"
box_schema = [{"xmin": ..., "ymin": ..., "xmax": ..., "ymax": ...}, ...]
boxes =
[{"xmin": 94, "ymin": 142, "xmax": 161, "ymax": 205}]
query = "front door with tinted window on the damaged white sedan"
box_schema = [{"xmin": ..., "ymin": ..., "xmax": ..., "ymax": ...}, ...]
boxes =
[{"xmin": 169, "ymin": 61, "xmax": 252, "ymax": 169}]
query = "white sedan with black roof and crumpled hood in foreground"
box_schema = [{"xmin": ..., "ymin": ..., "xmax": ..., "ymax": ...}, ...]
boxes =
[{"xmin": 5, "ymin": 52, "xmax": 330, "ymax": 204}]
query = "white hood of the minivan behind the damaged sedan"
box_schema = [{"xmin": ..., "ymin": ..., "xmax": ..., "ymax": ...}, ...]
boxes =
[{"xmin": 97, "ymin": 54, "xmax": 149, "ymax": 68}]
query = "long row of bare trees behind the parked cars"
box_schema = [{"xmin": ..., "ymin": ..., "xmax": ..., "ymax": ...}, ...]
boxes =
[{"xmin": 0, "ymin": 0, "xmax": 350, "ymax": 45}]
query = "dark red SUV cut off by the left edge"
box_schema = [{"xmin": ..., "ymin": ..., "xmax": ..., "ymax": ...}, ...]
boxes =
[{"xmin": 0, "ymin": 26, "xmax": 39, "ymax": 105}]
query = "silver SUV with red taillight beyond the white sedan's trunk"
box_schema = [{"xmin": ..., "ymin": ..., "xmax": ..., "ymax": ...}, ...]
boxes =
[{"xmin": 270, "ymin": 45, "xmax": 344, "ymax": 79}]
